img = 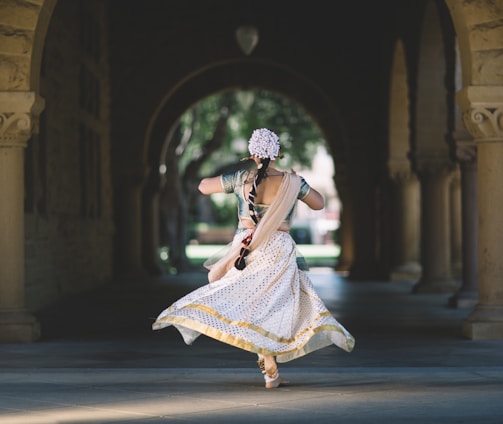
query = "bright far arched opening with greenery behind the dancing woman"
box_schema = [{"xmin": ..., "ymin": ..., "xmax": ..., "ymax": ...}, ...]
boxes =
[{"xmin": 144, "ymin": 89, "xmax": 340, "ymax": 272}]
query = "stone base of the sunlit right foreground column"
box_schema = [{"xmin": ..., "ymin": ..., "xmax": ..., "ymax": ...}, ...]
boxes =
[{"xmin": 462, "ymin": 305, "xmax": 503, "ymax": 340}]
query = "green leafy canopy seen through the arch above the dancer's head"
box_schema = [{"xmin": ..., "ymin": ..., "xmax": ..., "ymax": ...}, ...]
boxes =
[{"xmin": 179, "ymin": 90, "xmax": 324, "ymax": 177}]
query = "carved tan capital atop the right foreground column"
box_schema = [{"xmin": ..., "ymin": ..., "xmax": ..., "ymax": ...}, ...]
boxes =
[{"xmin": 456, "ymin": 86, "xmax": 503, "ymax": 143}]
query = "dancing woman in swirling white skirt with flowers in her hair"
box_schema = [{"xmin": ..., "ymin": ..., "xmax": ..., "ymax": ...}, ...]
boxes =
[{"xmin": 152, "ymin": 128, "xmax": 355, "ymax": 389}]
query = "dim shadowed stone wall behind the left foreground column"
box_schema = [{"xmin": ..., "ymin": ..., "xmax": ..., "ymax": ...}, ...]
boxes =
[{"xmin": 25, "ymin": 1, "xmax": 113, "ymax": 311}]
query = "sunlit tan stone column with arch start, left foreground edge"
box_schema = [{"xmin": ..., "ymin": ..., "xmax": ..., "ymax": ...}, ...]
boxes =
[{"xmin": 0, "ymin": 0, "xmax": 56, "ymax": 342}]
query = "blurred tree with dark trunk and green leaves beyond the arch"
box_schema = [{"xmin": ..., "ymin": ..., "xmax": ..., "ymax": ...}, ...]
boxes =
[{"xmin": 161, "ymin": 90, "xmax": 324, "ymax": 272}]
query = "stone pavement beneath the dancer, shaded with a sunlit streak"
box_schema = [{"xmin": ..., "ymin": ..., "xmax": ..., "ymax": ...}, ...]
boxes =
[{"xmin": 0, "ymin": 269, "xmax": 503, "ymax": 424}]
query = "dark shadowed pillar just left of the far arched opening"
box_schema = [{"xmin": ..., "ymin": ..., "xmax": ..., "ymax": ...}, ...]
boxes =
[{"xmin": 114, "ymin": 168, "xmax": 147, "ymax": 280}]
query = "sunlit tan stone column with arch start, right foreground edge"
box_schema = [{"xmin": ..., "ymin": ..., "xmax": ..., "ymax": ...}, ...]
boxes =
[{"xmin": 446, "ymin": 0, "xmax": 503, "ymax": 339}]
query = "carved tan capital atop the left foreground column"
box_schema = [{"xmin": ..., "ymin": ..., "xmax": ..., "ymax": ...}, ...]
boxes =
[{"xmin": 0, "ymin": 91, "xmax": 45, "ymax": 147}]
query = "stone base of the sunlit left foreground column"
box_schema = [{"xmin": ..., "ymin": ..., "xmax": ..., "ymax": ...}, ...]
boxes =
[{"xmin": 0, "ymin": 310, "xmax": 40, "ymax": 343}]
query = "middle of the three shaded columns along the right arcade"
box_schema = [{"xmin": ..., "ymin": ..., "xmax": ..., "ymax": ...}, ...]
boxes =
[{"xmin": 413, "ymin": 161, "xmax": 458, "ymax": 293}]
